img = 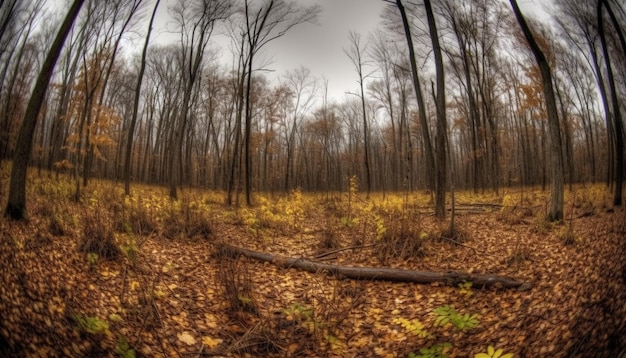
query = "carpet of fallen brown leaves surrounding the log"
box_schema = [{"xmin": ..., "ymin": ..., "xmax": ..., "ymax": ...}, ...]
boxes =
[{"xmin": 0, "ymin": 186, "xmax": 626, "ymax": 357}]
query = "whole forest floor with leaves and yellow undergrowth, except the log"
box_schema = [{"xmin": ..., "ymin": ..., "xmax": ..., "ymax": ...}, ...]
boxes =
[{"xmin": 0, "ymin": 172, "xmax": 626, "ymax": 357}]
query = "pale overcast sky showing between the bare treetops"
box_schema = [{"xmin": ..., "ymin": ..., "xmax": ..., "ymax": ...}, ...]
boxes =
[{"xmin": 48, "ymin": 0, "xmax": 545, "ymax": 101}]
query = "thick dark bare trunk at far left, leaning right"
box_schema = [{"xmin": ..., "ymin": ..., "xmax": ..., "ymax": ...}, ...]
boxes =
[{"xmin": 5, "ymin": 0, "xmax": 85, "ymax": 220}]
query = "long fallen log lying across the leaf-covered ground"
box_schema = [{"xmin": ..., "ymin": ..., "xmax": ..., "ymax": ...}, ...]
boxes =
[{"xmin": 220, "ymin": 245, "xmax": 532, "ymax": 290}]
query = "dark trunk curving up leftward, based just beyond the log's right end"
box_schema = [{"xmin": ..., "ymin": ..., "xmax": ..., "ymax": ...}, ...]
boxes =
[{"xmin": 510, "ymin": 0, "xmax": 564, "ymax": 222}]
